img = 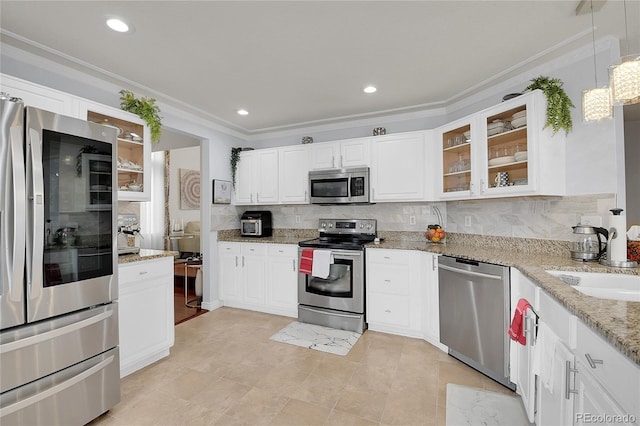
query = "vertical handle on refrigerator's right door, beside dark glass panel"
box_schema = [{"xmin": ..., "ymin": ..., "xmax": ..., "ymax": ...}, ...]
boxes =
[{"xmin": 27, "ymin": 128, "xmax": 44, "ymax": 299}]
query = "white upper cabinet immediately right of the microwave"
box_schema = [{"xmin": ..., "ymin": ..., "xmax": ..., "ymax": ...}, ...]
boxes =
[{"xmin": 371, "ymin": 131, "xmax": 432, "ymax": 202}]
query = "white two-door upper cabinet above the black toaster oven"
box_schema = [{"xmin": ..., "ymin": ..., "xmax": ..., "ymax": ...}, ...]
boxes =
[{"xmin": 235, "ymin": 148, "xmax": 278, "ymax": 205}]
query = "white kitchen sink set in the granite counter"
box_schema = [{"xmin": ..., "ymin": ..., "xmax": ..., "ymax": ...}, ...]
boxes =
[{"xmin": 547, "ymin": 270, "xmax": 640, "ymax": 302}]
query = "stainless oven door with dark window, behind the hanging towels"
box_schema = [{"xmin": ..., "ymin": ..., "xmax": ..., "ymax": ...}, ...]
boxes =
[{"xmin": 298, "ymin": 248, "xmax": 364, "ymax": 313}]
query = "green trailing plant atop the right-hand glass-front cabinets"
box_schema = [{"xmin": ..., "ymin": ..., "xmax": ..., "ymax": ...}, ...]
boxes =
[{"xmin": 527, "ymin": 76, "xmax": 574, "ymax": 134}]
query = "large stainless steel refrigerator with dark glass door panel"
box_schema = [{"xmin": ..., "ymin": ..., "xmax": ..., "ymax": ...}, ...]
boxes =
[{"xmin": 0, "ymin": 94, "xmax": 120, "ymax": 425}]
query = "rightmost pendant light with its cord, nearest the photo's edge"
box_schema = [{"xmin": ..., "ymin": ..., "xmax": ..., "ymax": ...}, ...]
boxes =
[{"xmin": 610, "ymin": 0, "xmax": 640, "ymax": 105}]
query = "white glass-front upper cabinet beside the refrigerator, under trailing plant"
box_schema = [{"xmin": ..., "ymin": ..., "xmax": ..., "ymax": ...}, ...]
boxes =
[{"xmin": 81, "ymin": 104, "xmax": 151, "ymax": 201}]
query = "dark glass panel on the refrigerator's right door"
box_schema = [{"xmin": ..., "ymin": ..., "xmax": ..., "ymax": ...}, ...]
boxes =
[{"xmin": 42, "ymin": 130, "xmax": 113, "ymax": 287}]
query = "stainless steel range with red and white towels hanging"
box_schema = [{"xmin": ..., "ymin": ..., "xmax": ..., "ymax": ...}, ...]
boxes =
[{"xmin": 298, "ymin": 219, "xmax": 377, "ymax": 333}]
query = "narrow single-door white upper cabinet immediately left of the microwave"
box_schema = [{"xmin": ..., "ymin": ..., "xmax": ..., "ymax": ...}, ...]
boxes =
[{"xmin": 278, "ymin": 145, "xmax": 311, "ymax": 204}]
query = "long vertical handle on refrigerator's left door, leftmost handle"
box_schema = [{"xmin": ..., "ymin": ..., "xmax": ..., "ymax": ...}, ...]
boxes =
[{"xmin": 3, "ymin": 127, "xmax": 27, "ymax": 301}]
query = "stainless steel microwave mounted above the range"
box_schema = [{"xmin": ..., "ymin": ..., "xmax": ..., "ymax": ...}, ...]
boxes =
[{"xmin": 309, "ymin": 167, "xmax": 369, "ymax": 204}]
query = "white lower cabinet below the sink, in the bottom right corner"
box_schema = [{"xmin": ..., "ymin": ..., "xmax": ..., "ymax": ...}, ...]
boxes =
[{"xmin": 536, "ymin": 274, "xmax": 640, "ymax": 426}]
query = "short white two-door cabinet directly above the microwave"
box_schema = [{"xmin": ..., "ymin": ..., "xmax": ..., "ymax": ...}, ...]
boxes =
[{"xmin": 310, "ymin": 138, "xmax": 371, "ymax": 170}]
